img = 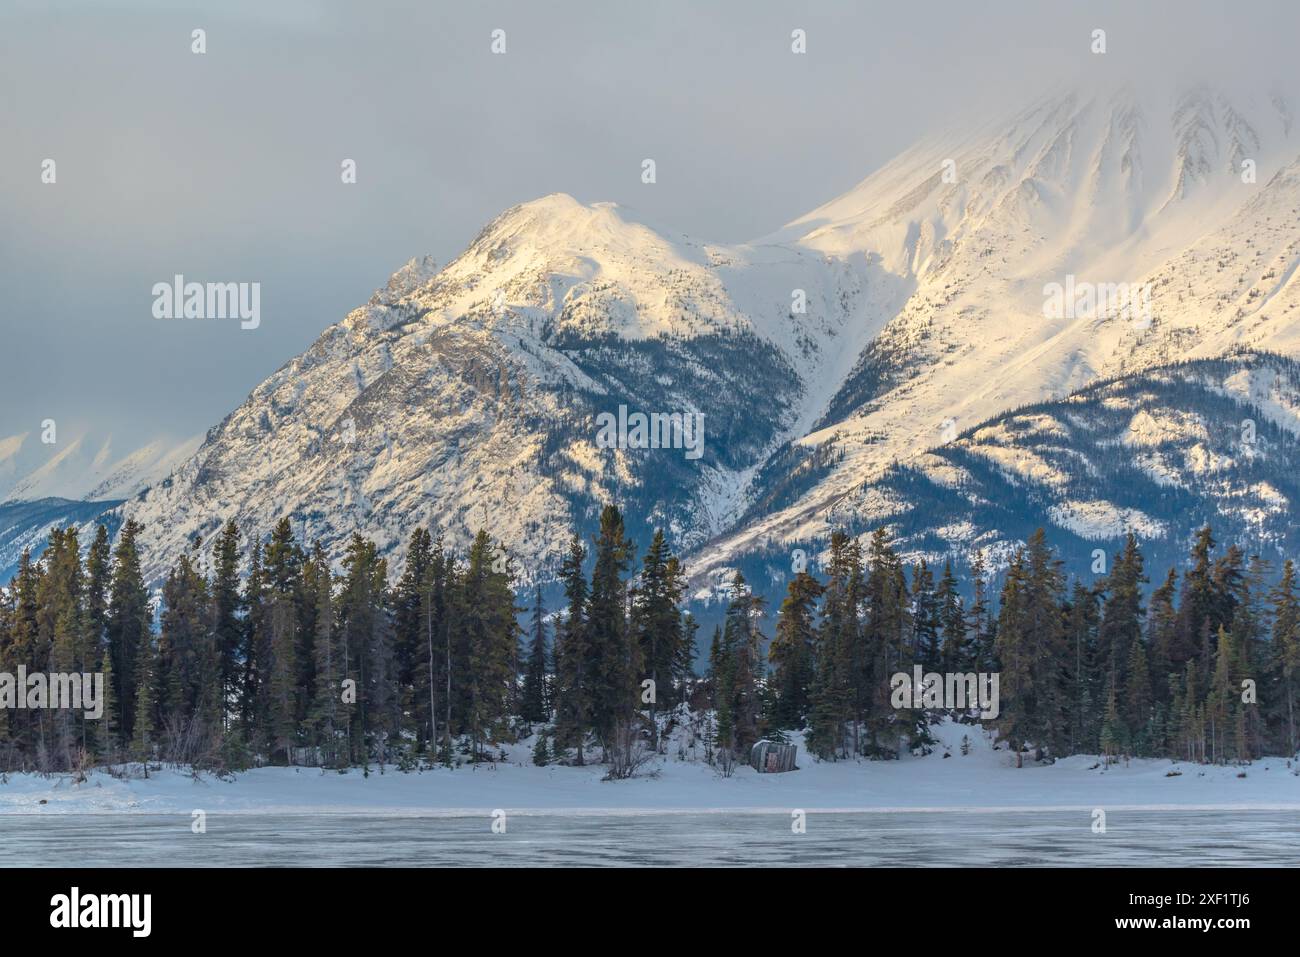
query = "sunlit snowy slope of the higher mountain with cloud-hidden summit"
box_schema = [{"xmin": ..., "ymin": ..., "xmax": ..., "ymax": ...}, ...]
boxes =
[{"xmin": 693, "ymin": 82, "xmax": 1300, "ymax": 583}]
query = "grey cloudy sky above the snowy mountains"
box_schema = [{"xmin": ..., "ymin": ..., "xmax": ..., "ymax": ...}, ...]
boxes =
[{"xmin": 0, "ymin": 0, "xmax": 1300, "ymax": 451}]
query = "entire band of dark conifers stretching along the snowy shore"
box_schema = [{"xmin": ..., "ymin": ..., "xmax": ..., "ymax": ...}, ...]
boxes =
[{"xmin": 0, "ymin": 506, "xmax": 1300, "ymax": 778}]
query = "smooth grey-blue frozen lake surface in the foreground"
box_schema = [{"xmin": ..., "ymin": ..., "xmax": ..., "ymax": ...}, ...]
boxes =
[{"xmin": 0, "ymin": 809, "xmax": 1300, "ymax": 867}]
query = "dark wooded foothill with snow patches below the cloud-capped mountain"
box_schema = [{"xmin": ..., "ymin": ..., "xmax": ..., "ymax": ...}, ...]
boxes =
[{"xmin": 716, "ymin": 351, "xmax": 1300, "ymax": 589}]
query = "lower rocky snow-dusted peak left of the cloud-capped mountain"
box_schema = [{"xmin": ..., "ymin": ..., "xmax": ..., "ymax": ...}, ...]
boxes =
[{"xmin": 126, "ymin": 195, "xmax": 901, "ymax": 580}]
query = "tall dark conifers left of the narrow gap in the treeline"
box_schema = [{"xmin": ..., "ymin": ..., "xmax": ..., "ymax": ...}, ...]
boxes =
[{"xmin": 0, "ymin": 507, "xmax": 696, "ymax": 771}]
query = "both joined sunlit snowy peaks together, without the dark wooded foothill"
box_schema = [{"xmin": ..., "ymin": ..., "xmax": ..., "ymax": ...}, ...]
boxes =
[{"xmin": 106, "ymin": 88, "xmax": 1300, "ymax": 600}]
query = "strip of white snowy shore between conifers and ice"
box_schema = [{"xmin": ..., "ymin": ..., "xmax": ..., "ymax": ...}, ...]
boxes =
[{"xmin": 0, "ymin": 723, "xmax": 1300, "ymax": 819}]
